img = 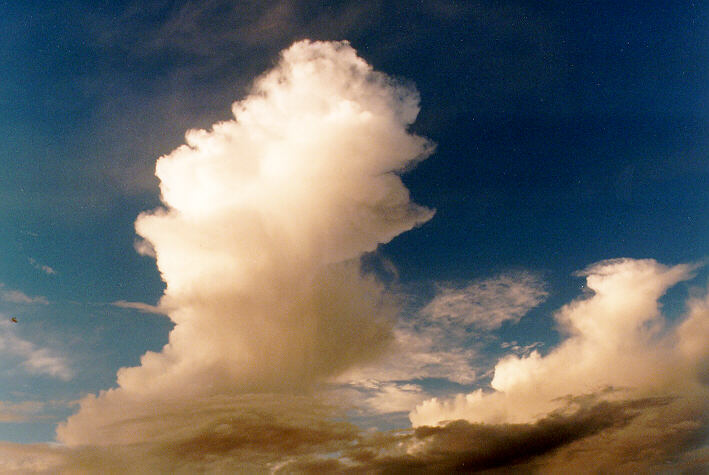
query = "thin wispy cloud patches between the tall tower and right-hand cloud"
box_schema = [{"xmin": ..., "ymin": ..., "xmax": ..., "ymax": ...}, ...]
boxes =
[{"xmin": 338, "ymin": 272, "xmax": 547, "ymax": 394}]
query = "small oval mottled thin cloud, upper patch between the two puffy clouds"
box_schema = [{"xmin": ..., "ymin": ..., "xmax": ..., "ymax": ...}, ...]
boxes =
[{"xmin": 423, "ymin": 272, "xmax": 548, "ymax": 330}]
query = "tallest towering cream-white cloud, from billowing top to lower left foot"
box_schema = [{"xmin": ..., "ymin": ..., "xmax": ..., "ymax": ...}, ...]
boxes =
[{"xmin": 58, "ymin": 41, "xmax": 433, "ymax": 445}]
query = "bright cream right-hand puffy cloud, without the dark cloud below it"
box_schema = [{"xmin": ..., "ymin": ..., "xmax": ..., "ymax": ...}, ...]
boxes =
[{"xmin": 410, "ymin": 259, "xmax": 709, "ymax": 426}]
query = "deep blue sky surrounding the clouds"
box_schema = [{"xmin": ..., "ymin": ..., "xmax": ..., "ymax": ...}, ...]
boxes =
[{"xmin": 0, "ymin": 1, "xmax": 709, "ymax": 441}]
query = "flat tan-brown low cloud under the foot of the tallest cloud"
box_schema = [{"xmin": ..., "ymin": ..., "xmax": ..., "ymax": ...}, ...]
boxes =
[{"xmin": 0, "ymin": 394, "xmax": 359, "ymax": 473}]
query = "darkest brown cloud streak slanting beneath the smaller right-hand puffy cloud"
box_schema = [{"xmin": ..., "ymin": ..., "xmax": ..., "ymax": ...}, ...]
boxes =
[{"xmin": 338, "ymin": 398, "xmax": 671, "ymax": 473}]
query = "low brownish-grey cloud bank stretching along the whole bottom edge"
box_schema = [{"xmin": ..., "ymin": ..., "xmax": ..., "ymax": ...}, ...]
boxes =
[{"xmin": 0, "ymin": 395, "xmax": 706, "ymax": 473}]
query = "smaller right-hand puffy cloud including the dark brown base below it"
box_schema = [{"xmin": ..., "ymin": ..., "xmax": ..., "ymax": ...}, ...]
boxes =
[{"xmin": 388, "ymin": 259, "xmax": 709, "ymax": 473}]
